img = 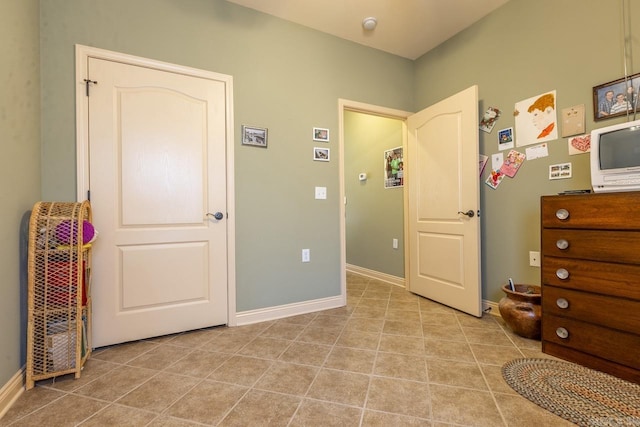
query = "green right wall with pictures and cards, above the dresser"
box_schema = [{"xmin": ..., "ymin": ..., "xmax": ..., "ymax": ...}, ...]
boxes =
[{"xmin": 415, "ymin": 0, "xmax": 640, "ymax": 301}]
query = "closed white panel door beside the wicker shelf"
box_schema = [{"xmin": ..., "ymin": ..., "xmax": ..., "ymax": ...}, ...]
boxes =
[{"xmin": 88, "ymin": 58, "xmax": 228, "ymax": 347}]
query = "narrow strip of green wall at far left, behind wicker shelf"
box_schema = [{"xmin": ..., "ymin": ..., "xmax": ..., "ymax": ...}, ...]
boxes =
[{"xmin": 0, "ymin": 0, "xmax": 40, "ymax": 388}]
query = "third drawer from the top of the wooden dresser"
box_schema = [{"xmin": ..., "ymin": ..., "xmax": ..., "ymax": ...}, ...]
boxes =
[{"xmin": 542, "ymin": 256, "xmax": 640, "ymax": 300}]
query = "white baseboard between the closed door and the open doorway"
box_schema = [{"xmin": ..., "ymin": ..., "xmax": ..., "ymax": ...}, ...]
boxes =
[{"xmin": 236, "ymin": 295, "xmax": 347, "ymax": 326}]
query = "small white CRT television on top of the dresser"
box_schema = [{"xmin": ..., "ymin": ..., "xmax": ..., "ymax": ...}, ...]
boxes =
[{"xmin": 591, "ymin": 120, "xmax": 640, "ymax": 193}]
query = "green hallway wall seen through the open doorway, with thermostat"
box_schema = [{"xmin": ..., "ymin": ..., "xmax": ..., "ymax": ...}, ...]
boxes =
[{"xmin": 344, "ymin": 111, "xmax": 404, "ymax": 277}]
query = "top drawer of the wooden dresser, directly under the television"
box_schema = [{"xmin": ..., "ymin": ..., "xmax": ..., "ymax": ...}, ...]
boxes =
[{"xmin": 541, "ymin": 191, "xmax": 640, "ymax": 230}]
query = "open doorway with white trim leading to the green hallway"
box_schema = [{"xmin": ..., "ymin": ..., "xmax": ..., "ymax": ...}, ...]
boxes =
[{"xmin": 339, "ymin": 99, "xmax": 412, "ymax": 295}]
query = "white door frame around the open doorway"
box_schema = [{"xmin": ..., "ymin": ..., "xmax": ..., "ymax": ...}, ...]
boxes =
[{"xmin": 338, "ymin": 98, "xmax": 414, "ymax": 294}]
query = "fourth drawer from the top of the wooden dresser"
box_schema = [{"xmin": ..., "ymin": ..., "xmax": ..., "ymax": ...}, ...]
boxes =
[{"xmin": 542, "ymin": 286, "xmax": 640, "ymax": 335}]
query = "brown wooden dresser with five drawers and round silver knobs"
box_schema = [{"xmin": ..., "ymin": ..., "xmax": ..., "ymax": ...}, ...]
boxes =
[{"xmin": 541, "ymin": 192, "xmax": 640, "ymax": 383}]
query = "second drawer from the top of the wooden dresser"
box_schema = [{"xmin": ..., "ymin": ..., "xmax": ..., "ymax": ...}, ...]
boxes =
[{"xmin": 541, "ymin": 228, "xmax": 640, "ymax": 264}]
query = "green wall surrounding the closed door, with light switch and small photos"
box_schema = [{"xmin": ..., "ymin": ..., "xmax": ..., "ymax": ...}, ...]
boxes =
[{"xmin": 41, "ymin": 0, "xmax": 413, "ymax": 311}]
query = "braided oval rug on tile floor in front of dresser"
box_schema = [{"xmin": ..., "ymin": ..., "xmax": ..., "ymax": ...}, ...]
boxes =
[{"xmin": 502, "ymin": 358, "xmax": 640, "ymax": 427}]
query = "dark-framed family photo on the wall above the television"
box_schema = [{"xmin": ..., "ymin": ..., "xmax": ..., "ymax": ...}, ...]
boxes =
[{"xmin": 593, "ymin": 73, "xmax": 640, "ymax": 121}]
